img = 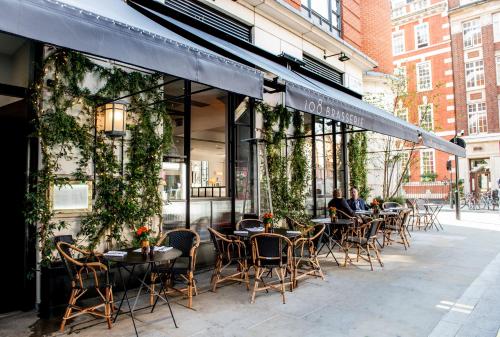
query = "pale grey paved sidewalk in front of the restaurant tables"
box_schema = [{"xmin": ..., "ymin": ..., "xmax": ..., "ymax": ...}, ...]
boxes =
[{"xmin": 0, "ymin": 212, "xmax": 500, "ymax": 337}]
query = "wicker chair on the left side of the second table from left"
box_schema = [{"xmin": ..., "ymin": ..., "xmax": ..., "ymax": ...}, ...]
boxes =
[{"xmin": 208, "ymin": 227, "xmax": 250, "ymax": 292}]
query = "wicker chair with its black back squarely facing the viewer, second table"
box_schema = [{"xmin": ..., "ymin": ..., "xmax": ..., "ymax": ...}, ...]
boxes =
[{"xmin": 250, "ymin": 233, "xmax": 293, "ymax": 304}]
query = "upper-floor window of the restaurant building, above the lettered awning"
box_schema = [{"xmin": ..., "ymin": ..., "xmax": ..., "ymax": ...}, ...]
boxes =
[{"xmin": 302, "ymin": 0, "xmax": 341, "ymax": 35}]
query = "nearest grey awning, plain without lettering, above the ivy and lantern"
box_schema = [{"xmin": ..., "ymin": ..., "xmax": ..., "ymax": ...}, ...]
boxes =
[{"xmin": 0, "ymin": 0, "xmax": 263, "ymax": 98}]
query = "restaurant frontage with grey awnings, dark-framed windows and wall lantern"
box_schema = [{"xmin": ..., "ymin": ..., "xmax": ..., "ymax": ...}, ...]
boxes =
[{"xmin": 0, "ymin": 0, "xmax": 464, "ymax": 312}]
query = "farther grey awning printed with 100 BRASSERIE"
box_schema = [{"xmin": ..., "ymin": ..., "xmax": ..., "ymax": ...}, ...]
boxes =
[{"xmin": 131, "ymin": 0, "xmax": 465, "ymax": 156}]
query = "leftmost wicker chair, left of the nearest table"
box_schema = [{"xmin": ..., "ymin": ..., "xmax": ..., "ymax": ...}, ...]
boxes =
[{"xmin": 56, "ymin": 238, "xmax": 114, "ymax": 332}]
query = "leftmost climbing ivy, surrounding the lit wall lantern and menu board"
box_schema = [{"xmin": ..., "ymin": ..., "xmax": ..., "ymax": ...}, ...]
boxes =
[{"xmin": 26, "ymin": 49, "xmax": 172, "ymax": 262}]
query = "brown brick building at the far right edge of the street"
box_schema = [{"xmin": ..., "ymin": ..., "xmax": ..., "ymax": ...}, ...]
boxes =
[{"xmin": 449, "ymin": 0, "xmax": 500, "ymax": 193}]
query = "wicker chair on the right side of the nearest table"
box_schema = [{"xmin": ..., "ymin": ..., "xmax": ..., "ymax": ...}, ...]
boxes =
[{"xmin": 150, "ymin": 229, "xmax": 200, "ymax": 309}]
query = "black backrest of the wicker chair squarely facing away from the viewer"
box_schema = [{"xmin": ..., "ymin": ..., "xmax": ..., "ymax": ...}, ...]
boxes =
[{"xmin": 251, "ymin": 233, "xmax": 292, "ymax": 266}]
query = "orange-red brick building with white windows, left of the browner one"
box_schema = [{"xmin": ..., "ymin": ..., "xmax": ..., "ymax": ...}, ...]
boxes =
[{"xmin": 392, "ymin": 0, "xmax": 455, "ymax": 197}]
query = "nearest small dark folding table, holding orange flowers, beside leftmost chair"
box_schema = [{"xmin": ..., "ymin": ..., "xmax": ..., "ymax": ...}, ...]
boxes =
[{"xmin": 104, "ymin": 248, "xmax": 182, "ymax": 336}]
